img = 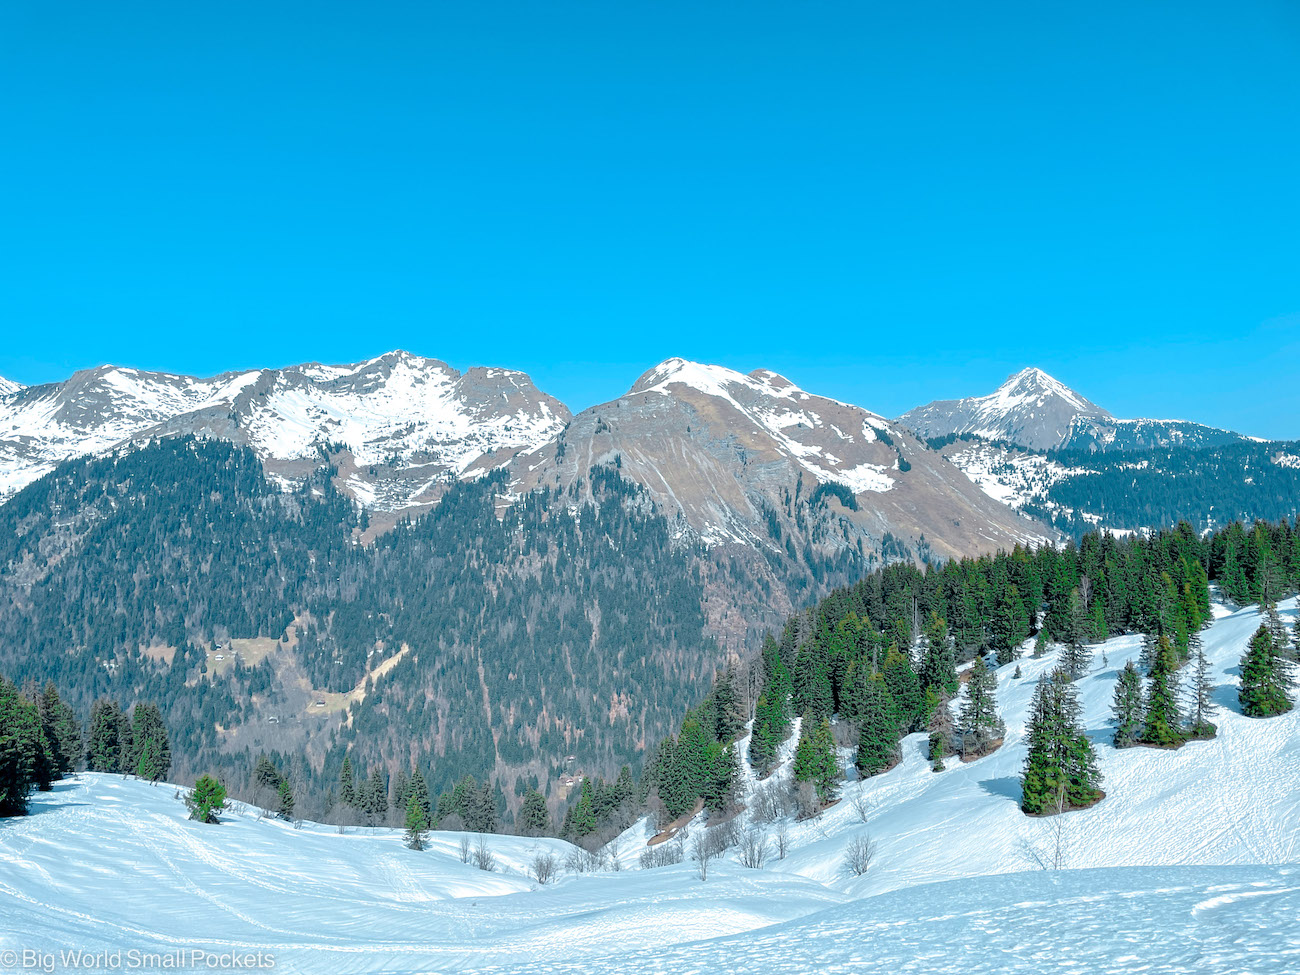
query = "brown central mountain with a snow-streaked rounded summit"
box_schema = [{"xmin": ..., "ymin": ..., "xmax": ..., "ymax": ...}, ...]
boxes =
[{"xmin": 508, "ymin": 359, "xmax": 1053, "ymax": 636}]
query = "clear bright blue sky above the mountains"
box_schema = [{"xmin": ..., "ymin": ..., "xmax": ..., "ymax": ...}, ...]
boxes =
[{"xmin": 0, "ymin": 0, "xmax": 1300, "ymax": 437}]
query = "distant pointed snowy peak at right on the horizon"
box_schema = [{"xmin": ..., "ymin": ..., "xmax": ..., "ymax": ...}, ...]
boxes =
[{"xmin": 898, "ymin": 368, "xmax": 1245, "ymax": 451}]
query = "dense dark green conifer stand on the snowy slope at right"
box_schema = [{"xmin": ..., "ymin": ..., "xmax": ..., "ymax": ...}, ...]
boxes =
[{"xmin": 646, "ymin": 520, "xmax": 1300, "ymax": 816}]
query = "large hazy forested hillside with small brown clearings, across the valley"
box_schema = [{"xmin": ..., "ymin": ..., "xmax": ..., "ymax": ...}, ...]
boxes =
[{"xmin": 0, "ymin": 438, "xmax": 719, "ymax": 811}]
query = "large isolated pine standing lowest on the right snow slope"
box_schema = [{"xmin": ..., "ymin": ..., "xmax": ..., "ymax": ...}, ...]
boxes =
[{"xmin": 1021, "ymin": 670, "xmax": 1101, "ymax": 815}]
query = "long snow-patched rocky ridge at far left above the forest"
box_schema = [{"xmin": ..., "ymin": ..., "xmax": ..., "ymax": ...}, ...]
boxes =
[{"xmin": 0, "ymin": 351, "xmax": 569, "ymax": 511}]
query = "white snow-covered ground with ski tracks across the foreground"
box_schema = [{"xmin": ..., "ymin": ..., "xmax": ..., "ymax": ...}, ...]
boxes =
[{"xmin": 0, "ymin": 602, "xmax": 1300, "ymax": 974}]
